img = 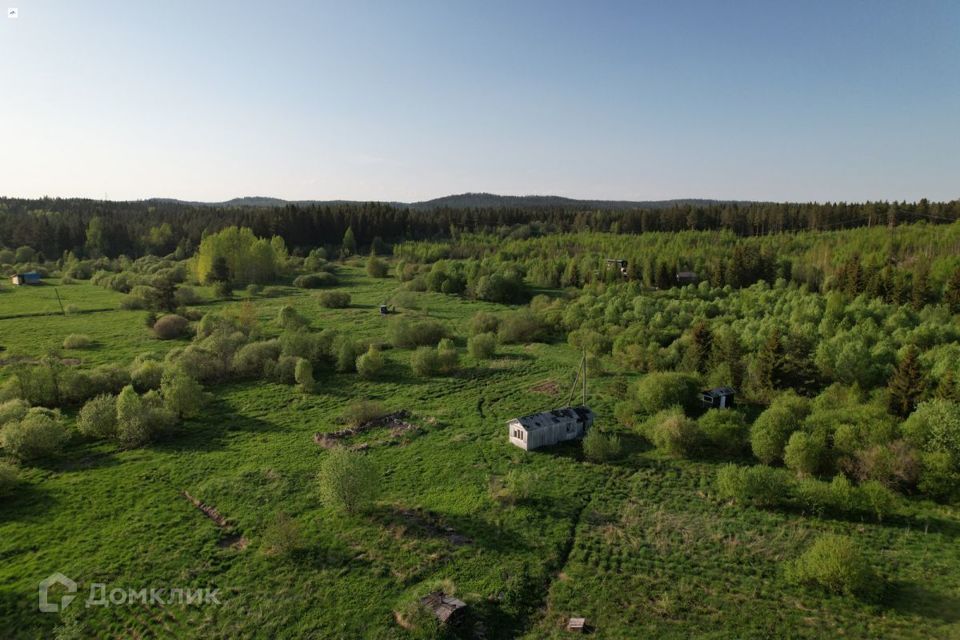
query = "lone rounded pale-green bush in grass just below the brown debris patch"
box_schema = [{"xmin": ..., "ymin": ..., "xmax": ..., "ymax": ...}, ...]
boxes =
[{"xmin": 317, "ymin": 447, "xmax": 380, "ymax": 513}]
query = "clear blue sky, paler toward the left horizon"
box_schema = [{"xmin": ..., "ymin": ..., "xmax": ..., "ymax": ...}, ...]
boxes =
[{"xmin": 0, "ymin": 0, "xmax": 960, "ymax": 201}]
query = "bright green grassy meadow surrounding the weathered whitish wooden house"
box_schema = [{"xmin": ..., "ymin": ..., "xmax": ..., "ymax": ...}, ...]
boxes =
[{"xmin": 0, "ymin": 271, "xmax": 960, "ymax": 638}]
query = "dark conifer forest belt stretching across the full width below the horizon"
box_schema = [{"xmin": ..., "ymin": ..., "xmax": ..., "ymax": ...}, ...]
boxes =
[{"xmin": 0, "ymin": 194, "xmax": 960, "ymax": 257}]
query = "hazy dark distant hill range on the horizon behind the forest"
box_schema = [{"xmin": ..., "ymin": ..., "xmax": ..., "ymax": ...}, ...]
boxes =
[{"xmin": 142, "ymin": 193, "xmax": 721, "ymax": 211}]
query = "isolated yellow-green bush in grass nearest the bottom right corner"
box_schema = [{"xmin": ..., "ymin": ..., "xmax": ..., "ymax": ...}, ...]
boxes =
[{"xmin": 787, "ymin": 534, "xmax": 880, "ymax": 598}]
